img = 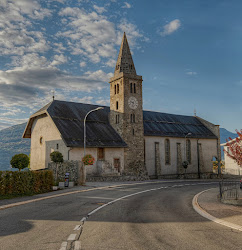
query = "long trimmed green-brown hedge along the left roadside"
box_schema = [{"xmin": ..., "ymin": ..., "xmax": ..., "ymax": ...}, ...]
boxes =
[{"xmin": 0, "ymin": 170, "xmax": 54, "ymax": 195}]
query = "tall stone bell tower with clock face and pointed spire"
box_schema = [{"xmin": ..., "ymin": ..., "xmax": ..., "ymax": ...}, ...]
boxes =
[{"xmin": 110, "ymin": 33, "xmax": 145, "ymax": 174}]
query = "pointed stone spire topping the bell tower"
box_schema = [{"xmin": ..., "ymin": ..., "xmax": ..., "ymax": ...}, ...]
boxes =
[{"xmin": 114, "ymin": 32, "xmax": 136, "ymax": 75}]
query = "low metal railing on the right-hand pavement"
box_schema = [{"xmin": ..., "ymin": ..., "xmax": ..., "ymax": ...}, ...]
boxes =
[{"xmin": 219, "ymin": 180, "xmax": 242, "ymax": 200}]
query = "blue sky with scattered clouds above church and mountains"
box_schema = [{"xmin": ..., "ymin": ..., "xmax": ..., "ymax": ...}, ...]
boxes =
[{"xmin": 0, "ymin": 0, "xmax": 242, "ymax": 132}]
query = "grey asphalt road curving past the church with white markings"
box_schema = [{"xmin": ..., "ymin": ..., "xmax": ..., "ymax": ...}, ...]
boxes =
[{"xmin": 0, "ymin": 181, "xmax": 242, "ymax": 250}]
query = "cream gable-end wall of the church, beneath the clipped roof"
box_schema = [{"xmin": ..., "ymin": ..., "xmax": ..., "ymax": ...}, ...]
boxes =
[{"xmin": 30, "ymin": 115, "xmax": 67, "ymax": 170}]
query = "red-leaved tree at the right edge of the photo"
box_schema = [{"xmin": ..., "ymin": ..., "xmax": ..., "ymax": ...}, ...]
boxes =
[{"xmin": 224, "ymin": 129, "xmax": 242, "ymax": 167}]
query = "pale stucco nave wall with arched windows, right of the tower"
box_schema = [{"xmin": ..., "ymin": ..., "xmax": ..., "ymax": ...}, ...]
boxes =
[{"xmin": 145, "ymin": 136, "xmax": 217, "ymax": 176}]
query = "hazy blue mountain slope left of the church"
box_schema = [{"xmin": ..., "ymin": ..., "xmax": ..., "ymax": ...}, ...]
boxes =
[{"xmin": 0, "ymin": 123, "xmax": 30, "ymax": 170}]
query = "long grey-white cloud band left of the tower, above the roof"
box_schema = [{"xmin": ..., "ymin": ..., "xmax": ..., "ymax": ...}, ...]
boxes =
[{"xmin": 0, "ymin": 62, "xmax": 113, "ymax": 106}]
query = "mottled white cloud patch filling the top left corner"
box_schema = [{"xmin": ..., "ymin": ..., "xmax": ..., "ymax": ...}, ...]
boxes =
[{"xmin": 0, "ymin": 0, "xmax": 51, "ymax": 56}]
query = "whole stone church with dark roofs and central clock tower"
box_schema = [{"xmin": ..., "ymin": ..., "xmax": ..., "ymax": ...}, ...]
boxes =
[{"xmin": 23, "ymin": 33, "xmax": 220, "ymax": 178}]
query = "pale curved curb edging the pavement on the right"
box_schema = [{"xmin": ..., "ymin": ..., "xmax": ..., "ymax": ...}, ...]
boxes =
[{"xmin": 192, "ymin": 188, "xmax": 242, "ymax": 232}]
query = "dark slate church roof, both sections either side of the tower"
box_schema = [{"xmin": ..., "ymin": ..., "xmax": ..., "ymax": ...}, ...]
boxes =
[{"xmin": 23, "ymin": 100, "xmax": 217, "ymax": 147}]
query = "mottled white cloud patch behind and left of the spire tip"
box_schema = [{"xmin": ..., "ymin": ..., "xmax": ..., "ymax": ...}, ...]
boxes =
[{"xmin": 56, "ymin": 6, "xmax": 144, "ymax": 67}]
